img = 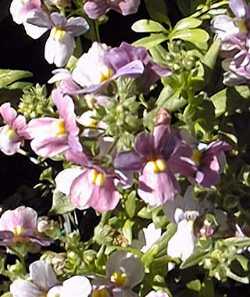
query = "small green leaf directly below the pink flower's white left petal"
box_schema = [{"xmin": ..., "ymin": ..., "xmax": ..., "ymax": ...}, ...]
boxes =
[{"xmin": 50, "ymin": 191, "xmax": 75, "ymax": 214}]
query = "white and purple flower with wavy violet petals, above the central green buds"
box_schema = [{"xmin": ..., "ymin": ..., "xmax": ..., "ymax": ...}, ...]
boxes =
[{"xmin": 72, "ymin": 42, "xmax": 171, "ymax": 93}]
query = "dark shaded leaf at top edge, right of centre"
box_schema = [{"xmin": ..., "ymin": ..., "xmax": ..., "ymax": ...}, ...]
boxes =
[{"xmin": 144, "ymin": 0, "xmax": 170, "ymax": 25}]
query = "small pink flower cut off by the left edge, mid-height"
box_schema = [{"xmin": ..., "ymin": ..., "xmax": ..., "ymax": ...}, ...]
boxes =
[{"xmin": 0, "ymin": 103, "xmax": 29, "ymax": 155}]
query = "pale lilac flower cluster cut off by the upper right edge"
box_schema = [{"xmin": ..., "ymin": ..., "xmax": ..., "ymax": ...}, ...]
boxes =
[{"xmin": 213, "ymin": 0, "xmax": 250, "ymax": 86}]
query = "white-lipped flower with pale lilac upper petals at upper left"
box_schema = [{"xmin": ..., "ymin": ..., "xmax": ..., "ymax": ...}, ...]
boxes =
[{"xmin": 27, "ymin": 10, "xmax": 89, "ymax": 67}]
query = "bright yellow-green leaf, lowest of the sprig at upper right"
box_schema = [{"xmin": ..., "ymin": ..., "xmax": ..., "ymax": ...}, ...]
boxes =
[{"xmin": 169, "ymin": 29, "xmax": 209, "ymax": 50}]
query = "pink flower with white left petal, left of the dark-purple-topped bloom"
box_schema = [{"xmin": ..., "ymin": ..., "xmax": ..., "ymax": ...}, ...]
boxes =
[{"xmin": 56, "ymin": 158, "xmax": 120, "ymax": 212}]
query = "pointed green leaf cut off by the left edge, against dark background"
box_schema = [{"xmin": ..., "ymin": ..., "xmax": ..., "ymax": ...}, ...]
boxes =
[{"xmin": 0, "ymin": 69, "xmax": 32, "ymax": 88}]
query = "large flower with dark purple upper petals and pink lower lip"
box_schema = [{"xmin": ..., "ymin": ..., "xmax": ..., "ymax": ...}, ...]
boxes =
[{"xmin": 115, "ymin": 120, "xmax": 195, "ymax": 206}]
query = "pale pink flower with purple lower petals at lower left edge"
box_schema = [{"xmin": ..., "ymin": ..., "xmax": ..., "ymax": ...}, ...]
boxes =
[{"xmin": 0, "ymin": 206, "xmax": 51, "ymax": 246}]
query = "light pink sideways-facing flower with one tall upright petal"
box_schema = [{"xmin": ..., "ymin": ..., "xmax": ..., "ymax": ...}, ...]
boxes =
[{"xmin": 28, "ymin": 90, "xmax": 82, "ymax": 158}]
